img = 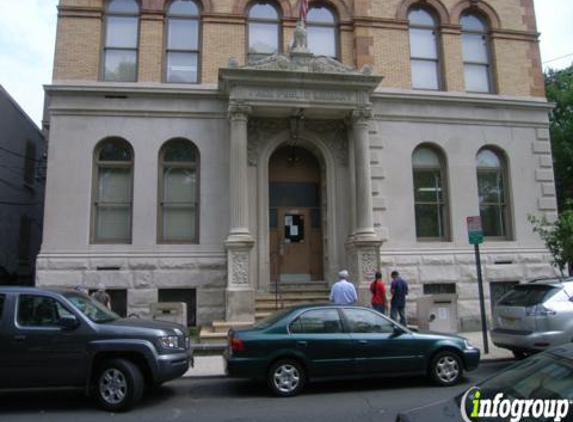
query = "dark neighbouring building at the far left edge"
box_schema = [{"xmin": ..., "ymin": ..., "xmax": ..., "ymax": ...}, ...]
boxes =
[{"xmin": 0, "ymin": 85, "xmax": 47, "ymax": 285}]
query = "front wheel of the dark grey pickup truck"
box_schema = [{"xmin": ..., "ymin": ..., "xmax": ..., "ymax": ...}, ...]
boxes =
[{"xmin": 95, "ymin": 359, "xmax": 145, "ymax": 412}]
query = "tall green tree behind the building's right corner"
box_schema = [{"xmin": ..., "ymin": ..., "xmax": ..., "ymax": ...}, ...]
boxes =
[{"xmin": 545, "ymin": 65, "xmax": 573, "ymax": 209}]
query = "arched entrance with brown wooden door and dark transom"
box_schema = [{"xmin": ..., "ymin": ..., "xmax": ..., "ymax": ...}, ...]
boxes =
[{"xmin": 269, "ymin": 146, "xmax": 324, "ymax": 283}]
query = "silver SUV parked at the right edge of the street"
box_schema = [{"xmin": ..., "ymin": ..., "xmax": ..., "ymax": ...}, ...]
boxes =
[{"xmin": 491, "ymin": 277, "xmax": 573, "ymax": 358}]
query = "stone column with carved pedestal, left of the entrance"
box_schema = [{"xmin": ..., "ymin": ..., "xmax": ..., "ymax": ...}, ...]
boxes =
[{"xmin": 225, "ymin": 101, "xmax": 255, "ymax": 322}]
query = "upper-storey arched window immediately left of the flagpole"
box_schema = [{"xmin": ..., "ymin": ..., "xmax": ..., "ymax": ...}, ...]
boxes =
[{"xmin": 248, "ymin": 0, "xmax": 280, "ymax": 63}]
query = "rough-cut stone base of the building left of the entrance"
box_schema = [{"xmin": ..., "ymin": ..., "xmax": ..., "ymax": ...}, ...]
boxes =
[{"xmin": 36, "ymin": 256, "xmax": 227, "ymax": 325}]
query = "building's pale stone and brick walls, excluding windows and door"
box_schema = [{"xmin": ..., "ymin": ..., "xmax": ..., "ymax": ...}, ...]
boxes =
[{"xmin": 41, "ymin": 0, "xmax": 556, "ymax": 329}]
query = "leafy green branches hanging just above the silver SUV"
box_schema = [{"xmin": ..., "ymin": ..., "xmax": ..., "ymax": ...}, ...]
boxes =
[{"xmin": 527, "ymin": 201, "xmax": 573, "ymax": 275}]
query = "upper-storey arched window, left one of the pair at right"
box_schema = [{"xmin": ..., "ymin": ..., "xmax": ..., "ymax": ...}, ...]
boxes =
[{"xmin": 408, "ymin": 7, "xmax": 441, "ymax": 89}]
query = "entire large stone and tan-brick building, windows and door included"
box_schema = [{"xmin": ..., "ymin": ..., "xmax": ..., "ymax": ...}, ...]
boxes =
[{"xmin": 37, "ymin": 0, "xmax": 556, "ymax": 329}]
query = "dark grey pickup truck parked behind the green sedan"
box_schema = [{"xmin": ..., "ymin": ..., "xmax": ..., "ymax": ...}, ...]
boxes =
[{"xmin": 0, "ymin": 287, "xmax": 193, "ymax": 412}]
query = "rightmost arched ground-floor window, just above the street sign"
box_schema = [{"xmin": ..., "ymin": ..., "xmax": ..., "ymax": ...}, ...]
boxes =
[{"xmin": 476, "ymin": 148, "xmax": 510, "ymax": 239}]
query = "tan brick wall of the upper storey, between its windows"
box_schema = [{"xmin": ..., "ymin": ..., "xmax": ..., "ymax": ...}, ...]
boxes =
[{"xmin": 54, "ymin": 0, "xmax": 544, "ymax": 97}]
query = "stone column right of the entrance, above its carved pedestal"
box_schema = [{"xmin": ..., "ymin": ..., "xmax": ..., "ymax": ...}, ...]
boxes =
[{"xmin": 352, "ymin": 107, "xmax": 376, "ymax": 240}]
